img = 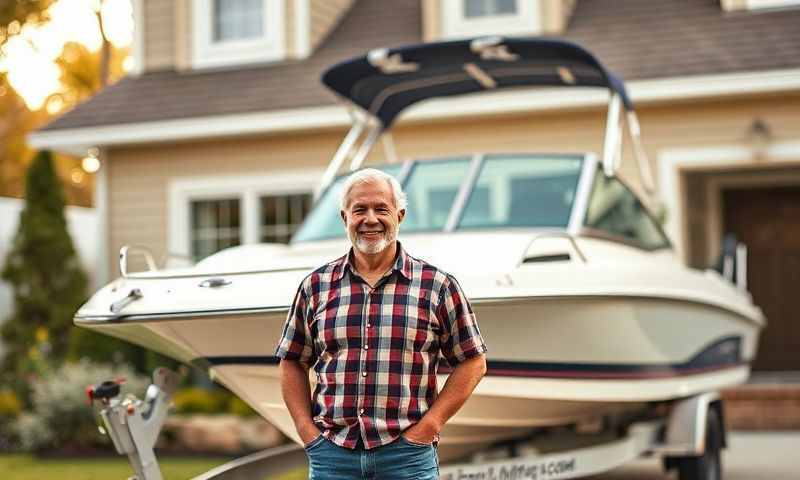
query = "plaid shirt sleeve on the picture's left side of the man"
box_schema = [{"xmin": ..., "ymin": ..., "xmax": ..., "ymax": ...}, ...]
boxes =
[{"xmin": 275, "ymin": 281, "xmax": 316, "ymax": 365}]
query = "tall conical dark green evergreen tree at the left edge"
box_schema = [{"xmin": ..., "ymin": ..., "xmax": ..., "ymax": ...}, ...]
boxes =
[{"xmin": 0, "ymin": 151, "xmax": 87, "ymax": 382}]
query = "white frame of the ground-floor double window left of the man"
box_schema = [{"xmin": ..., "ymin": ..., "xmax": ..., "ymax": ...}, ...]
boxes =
[{"xmin": 167, "ymin": 168, "xmax": 323, "ymax": 258}]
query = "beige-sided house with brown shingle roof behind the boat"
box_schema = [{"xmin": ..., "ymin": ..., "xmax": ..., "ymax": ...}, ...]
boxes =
[{"xmin": 30, "ymin": 0, "xmax": 800, "ymax": 371}]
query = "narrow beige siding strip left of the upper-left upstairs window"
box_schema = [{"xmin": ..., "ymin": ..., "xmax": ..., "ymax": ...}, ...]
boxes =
[{"xmin": 142, "ymin": 0, "xmax": 175, "ymax": 71}]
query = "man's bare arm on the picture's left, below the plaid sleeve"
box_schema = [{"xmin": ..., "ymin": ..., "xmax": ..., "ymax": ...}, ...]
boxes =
[{"xmin": 278, "ymin": 359, "xmax": 320, "ymax": 444}]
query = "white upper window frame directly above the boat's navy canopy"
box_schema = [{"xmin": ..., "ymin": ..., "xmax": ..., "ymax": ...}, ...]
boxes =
[{"xmin": 441, "ymin": 0, "xmax": 543, "ymax": 39}]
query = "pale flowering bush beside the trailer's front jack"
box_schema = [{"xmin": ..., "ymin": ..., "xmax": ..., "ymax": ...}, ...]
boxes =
[{"xmin": 14, "ymin": 360, "xmax": 150, "ymax": 452}]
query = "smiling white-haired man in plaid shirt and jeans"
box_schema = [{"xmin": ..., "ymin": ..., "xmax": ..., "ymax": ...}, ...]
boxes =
[{"xmin": 277, "ymin": 169, "xmax": 486, "ymax": 480}]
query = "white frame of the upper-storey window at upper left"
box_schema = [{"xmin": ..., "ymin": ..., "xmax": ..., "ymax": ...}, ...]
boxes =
[{"xmin": 192, "ymin": 0, "xmax": 286, "ymax": 69}]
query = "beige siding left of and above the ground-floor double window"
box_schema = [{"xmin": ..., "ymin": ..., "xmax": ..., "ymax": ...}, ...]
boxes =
[{"xmin": 108, "ymin": 132, "xmax": 339, "ymax": 278}]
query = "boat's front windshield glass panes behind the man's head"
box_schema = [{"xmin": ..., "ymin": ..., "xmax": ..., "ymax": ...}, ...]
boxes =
[{"xmin": 292, "ymin": 154, "xmax": 583, "ymax": 242}]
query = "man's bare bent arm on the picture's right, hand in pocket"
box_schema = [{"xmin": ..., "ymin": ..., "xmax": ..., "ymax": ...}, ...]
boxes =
[{"xmin": 403, "ymin": 355, "xmax": 486, "ymax": 443}]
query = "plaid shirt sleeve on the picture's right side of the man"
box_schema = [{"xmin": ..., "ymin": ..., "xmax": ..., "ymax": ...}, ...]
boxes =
[{"xmin": 436, "ymin": 275, "xmax": 486, "ymax": 367}]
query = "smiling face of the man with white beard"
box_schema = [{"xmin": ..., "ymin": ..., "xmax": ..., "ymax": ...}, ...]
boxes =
[{"xmin": 341, "ymin": 180, "xmax": 406, "ymax": 254}]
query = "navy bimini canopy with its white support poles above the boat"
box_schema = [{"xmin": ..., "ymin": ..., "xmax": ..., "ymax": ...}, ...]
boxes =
[{"xmin": 317, "ymin": 37, "xmax": 654, "ymax": 200}]
